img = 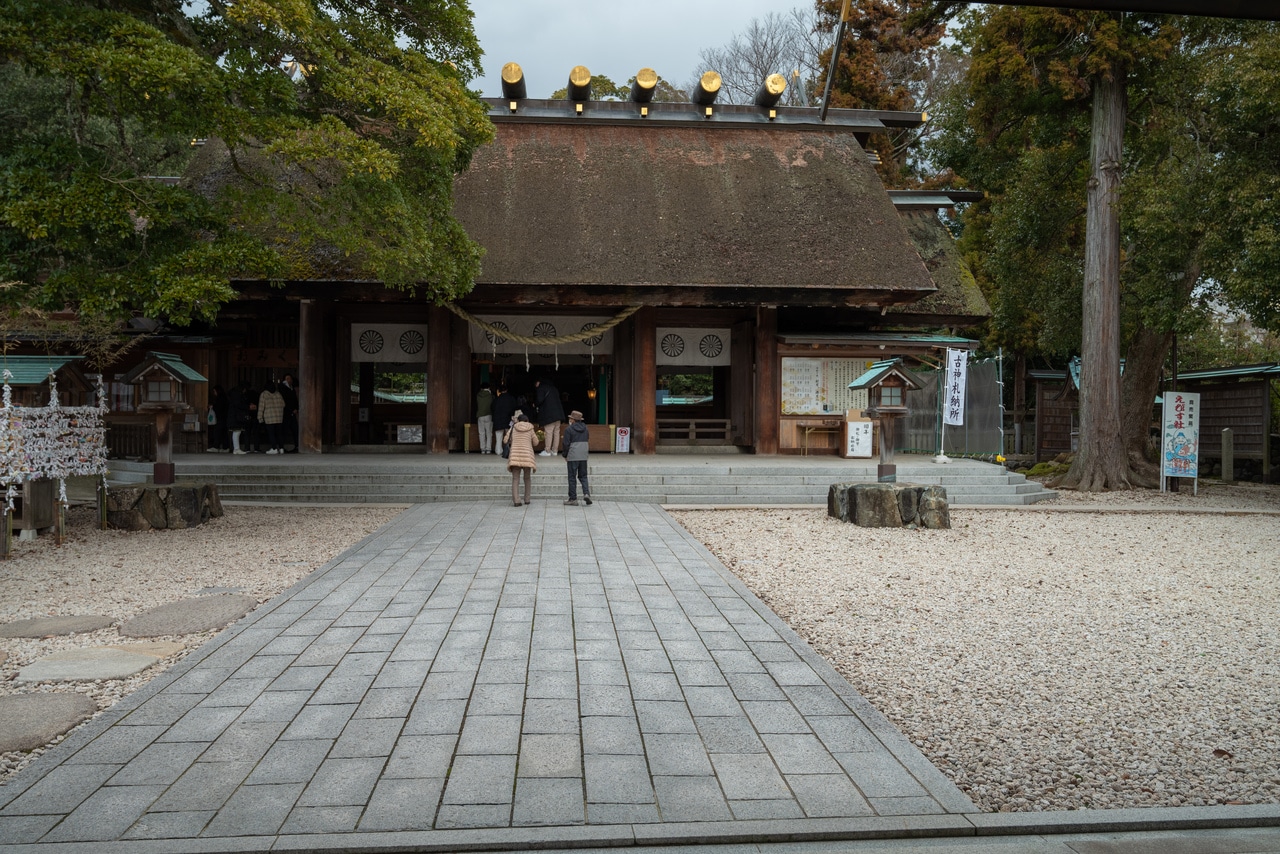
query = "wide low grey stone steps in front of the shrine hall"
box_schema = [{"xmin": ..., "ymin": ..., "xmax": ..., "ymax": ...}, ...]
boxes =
[{"xmin": 111, "ymin": 453, "xmax": 1057, "ymax": 506}]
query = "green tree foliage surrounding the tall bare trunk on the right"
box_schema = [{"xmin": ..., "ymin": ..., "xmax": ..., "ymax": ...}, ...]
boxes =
[{"xmin": 932, "ymin": 8, "xmax": 1280, "ymax": 357}]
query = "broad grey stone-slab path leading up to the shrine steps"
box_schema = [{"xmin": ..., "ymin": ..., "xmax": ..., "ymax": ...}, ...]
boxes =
[{"xmin": 0, "ymin": 502, "xmax": 975, "ymax": 851}]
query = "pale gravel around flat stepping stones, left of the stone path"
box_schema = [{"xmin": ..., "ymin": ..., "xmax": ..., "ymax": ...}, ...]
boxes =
[{"xmin": 0, "ymin": 504, "xmax": 403, "ymax": 784}]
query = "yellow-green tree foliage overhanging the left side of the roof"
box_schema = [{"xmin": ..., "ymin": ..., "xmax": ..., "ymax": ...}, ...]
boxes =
[{"xmin": 0, "ymin": 0, "xmax": 492, "ymax": 324}]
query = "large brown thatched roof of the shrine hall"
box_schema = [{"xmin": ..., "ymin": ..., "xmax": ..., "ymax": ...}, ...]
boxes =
[{"xmin": 454, "ymin": 117, "xmax": 936, "ymax": 306}]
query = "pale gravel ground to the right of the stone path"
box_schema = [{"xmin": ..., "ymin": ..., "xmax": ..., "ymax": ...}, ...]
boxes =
[{"xmin": 675, "ymin": 484, "xmax": 1280, "ymax": 812}]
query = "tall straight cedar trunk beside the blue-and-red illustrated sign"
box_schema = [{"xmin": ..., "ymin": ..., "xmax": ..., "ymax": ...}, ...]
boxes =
[{"xmin": 1062, "ymin": 60, "xmax": 1133, "ymax": 492}]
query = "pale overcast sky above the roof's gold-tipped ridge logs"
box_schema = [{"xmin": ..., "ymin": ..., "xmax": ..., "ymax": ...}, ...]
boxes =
[{"xmin": 471, "ymin": 0, "xmax": 788, "ymax": 97}]
